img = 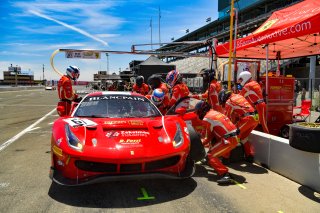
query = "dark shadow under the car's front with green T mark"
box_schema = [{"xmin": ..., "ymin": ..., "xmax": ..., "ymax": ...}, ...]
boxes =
[{"xmin": 48, "ymin": 178, "xmax": 197, "ymax": 208}]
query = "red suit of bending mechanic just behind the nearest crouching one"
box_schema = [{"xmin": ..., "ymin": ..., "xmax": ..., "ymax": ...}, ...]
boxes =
[{"xmin": 225, "ymin": 94, "xmax": 259, "ymax": 157}]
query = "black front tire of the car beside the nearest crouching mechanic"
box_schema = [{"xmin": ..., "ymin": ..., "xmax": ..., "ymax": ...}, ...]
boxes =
[{"xmin": 188, "ymin": 124, "xmax": 206, "ymax": 162}]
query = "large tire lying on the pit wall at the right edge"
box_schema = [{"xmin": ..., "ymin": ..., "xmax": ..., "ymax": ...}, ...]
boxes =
[{"xmin": 289, "ymin": 122, "xmax": 320, "ymax": 153}]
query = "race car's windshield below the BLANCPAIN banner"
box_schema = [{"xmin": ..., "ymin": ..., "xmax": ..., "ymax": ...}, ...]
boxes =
[{"xmin": 74, "ymin": 95, "xmax": 161, "ymax": 118}]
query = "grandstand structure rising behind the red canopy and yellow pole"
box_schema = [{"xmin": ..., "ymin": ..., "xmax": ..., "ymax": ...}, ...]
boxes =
[{"xmin": 158, "ymin": 0, "xmax": 302, "ymax": 75}]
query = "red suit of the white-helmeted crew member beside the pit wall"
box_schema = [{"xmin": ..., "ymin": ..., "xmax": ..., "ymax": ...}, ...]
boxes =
[{"xmin": 240, "ymin": 80, "xmax": 269, "ymax": 133}]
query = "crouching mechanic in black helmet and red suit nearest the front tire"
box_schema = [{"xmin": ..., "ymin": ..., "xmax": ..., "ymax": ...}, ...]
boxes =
[{"xmin": 195, "ymin": 101, "xmax": 239, "ymax": 184}]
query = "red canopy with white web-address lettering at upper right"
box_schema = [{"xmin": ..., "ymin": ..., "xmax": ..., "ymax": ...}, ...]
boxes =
[{"xmin": 216, "ymin": 0, "xmax": 320, "ymax": 59}]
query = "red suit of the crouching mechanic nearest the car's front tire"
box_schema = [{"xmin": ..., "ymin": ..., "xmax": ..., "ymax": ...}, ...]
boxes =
[{"xmin": 202, "ymin": 109, "xmax": 239, "ymax": 175}]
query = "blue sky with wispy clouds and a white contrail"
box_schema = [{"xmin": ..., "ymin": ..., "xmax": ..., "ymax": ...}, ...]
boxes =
[{"xmin": 0, "ymin": 0, "xmax": 218, "ymax": 81}]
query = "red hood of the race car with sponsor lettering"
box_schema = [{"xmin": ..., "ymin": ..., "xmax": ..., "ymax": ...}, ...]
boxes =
[{"xmin": 52, "ymin": 117, "xmax": 188, "ymax": 157}]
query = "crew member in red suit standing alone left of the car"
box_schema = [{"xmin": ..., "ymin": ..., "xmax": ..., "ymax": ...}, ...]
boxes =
[{"xmin": 58, "ymin": 66, "xmax": 81, "ymax": 116}]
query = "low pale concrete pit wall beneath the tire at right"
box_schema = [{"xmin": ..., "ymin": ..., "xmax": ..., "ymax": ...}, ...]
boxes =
[{"xmin": 249, "ymin": 131, "xmax": 320, "ymax": 192}]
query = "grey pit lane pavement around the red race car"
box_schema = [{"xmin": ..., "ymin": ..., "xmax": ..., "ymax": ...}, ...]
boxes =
[{"xmin": 0, "ymin": 90, "xmax": 320, "ymax": 213}]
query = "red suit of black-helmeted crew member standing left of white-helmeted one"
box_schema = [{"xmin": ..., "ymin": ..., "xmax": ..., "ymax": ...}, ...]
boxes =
[{"xmin": 191, "ymin": 79, "xmax": 223, "ymax": 112}]
